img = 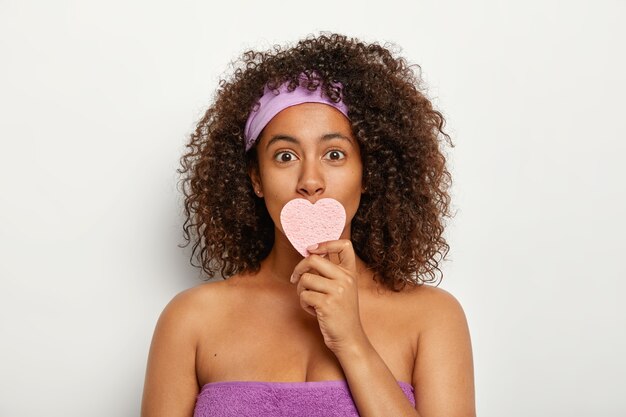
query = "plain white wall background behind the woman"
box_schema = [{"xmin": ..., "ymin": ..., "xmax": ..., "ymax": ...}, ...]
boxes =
[{"xmin": 0, "ymin": 0, "xmax": 626, "ymax": 417}]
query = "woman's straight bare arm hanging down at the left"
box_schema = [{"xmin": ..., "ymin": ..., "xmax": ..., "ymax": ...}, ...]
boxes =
[{"xmin": 141, "ymin": 289, "xmax": 199, "ymax": 417}]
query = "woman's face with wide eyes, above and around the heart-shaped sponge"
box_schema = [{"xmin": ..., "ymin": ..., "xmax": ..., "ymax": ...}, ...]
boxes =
[{"xmin": 250, "ymin": 103, "xmax": 363, "ymax": 239}]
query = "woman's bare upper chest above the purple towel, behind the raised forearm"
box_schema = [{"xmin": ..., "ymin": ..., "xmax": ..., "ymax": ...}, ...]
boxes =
[{"xmin": 196, "ymin": 283, "xmax": 419, "ymax": 385}]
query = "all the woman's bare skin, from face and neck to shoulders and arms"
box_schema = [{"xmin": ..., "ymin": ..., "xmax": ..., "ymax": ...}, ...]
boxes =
[{"xmin": 142, "ymin": 103, "xmax": 475, "ymax": 417}]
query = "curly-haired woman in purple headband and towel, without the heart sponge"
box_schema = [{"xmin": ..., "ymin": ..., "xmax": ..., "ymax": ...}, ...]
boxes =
[{"xmin": 142, "ymin": 34, "xmax": 475, "ymax": 417}]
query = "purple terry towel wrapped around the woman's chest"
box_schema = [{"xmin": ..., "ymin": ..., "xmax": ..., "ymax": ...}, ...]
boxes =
[{"xmin": 193, "ymin": 380, "xmax": 415, "ymax": 417}]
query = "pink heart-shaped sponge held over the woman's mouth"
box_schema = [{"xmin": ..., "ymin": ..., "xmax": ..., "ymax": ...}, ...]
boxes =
[{"xmin": 280, "ymin": 198, "xmax": 346, "ymax": 257}]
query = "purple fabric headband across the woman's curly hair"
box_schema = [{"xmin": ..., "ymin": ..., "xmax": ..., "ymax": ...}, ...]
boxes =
[{"xmin": 244, "ymin": 73, "xmax": 348, "ymax": 152}]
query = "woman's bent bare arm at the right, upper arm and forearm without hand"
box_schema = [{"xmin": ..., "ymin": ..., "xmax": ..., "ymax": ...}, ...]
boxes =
[{"xmin": 338, "ymin": 287, "xmax": 476, "ymax": 417}]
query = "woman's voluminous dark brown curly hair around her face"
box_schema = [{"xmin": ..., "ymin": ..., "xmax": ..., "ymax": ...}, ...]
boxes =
[{"xmin": 177, "ymin": 33, "xmax": 454, "ymax": 292}]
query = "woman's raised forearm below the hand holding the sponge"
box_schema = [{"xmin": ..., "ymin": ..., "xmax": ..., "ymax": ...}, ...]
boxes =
[{"xmin": 336, "ymin": 337, "xmax": 419, "ymax": 417}]
